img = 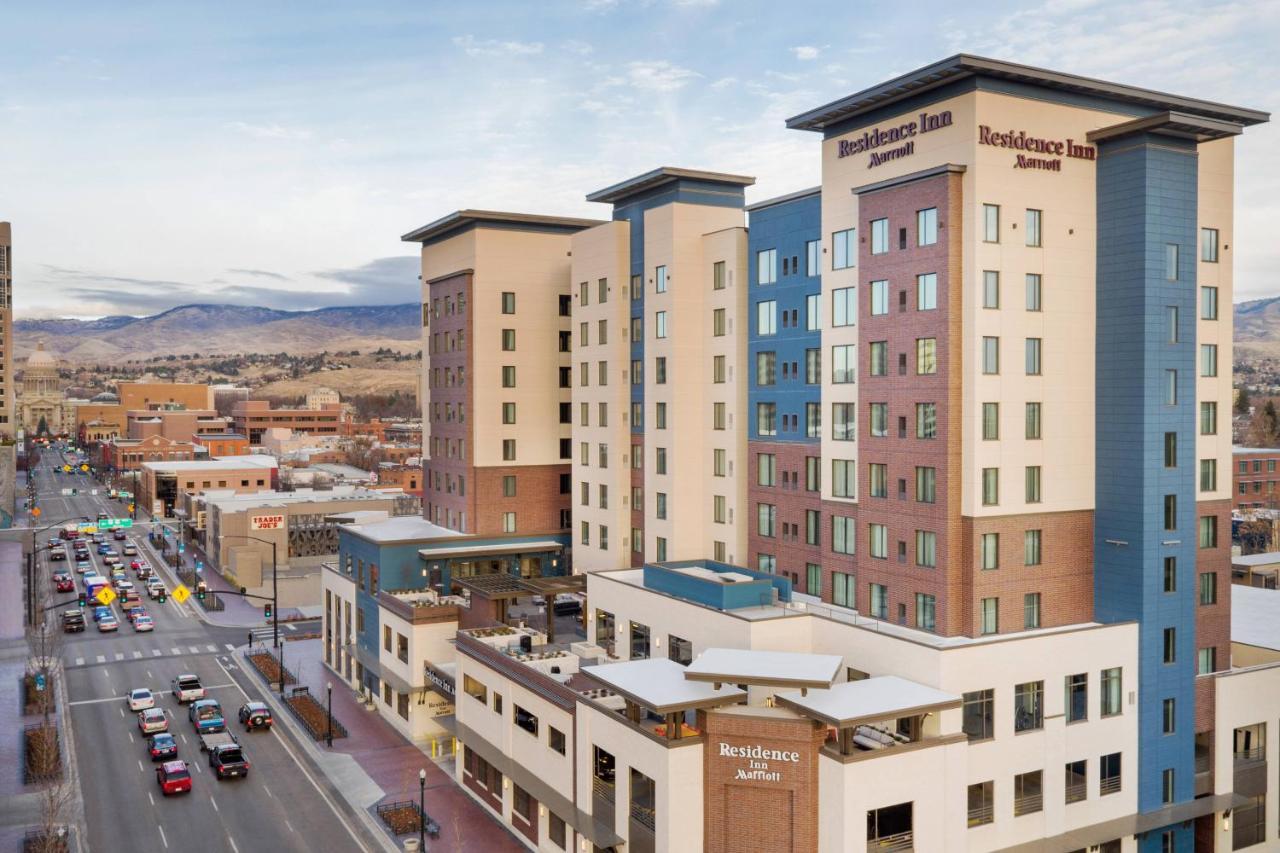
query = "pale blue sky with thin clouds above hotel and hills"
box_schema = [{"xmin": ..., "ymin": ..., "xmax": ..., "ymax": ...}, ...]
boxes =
[{"xmin": 0, "ymin": 0, "xmax": 1280, "ymax": 319}]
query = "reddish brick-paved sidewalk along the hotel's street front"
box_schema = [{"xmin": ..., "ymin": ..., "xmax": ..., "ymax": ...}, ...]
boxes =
[{"xmin": 272, "ymin": 639, "xmax": 527, "ymax": 853}]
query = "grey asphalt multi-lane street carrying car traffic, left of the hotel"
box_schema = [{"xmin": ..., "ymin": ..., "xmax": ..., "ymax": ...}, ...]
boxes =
[{"xmin": 35, "ymin": 451, "xmax": 372, "ymax": 853}]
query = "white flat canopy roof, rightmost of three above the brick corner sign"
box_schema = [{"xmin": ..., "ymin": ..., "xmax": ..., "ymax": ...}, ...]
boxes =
[{"xmin": 774, "ymin": 675, "xmax": 961, "ymax": 729}]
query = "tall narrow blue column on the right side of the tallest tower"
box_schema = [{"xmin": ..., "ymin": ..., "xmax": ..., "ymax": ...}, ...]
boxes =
[{"xmin": 1093, "ymin": 136, "xmax": 1197, "ymax": 835}]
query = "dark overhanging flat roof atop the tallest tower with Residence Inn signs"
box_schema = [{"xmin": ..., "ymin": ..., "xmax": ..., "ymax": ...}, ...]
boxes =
[{"xmin": 787, "ymin": 54, "xmax": 1271, "ymax": 131}]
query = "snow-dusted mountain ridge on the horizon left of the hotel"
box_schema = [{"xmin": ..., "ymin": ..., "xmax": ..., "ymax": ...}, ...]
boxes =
[{"xmin": 13, "ymin": 302, "xmax": 422, "ymax": 362}]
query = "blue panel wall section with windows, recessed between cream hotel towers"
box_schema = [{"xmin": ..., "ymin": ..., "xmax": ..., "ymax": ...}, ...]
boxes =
[{"xmin": 746, "ymin": 192, "xmax": 831, "ymax": 442}]
